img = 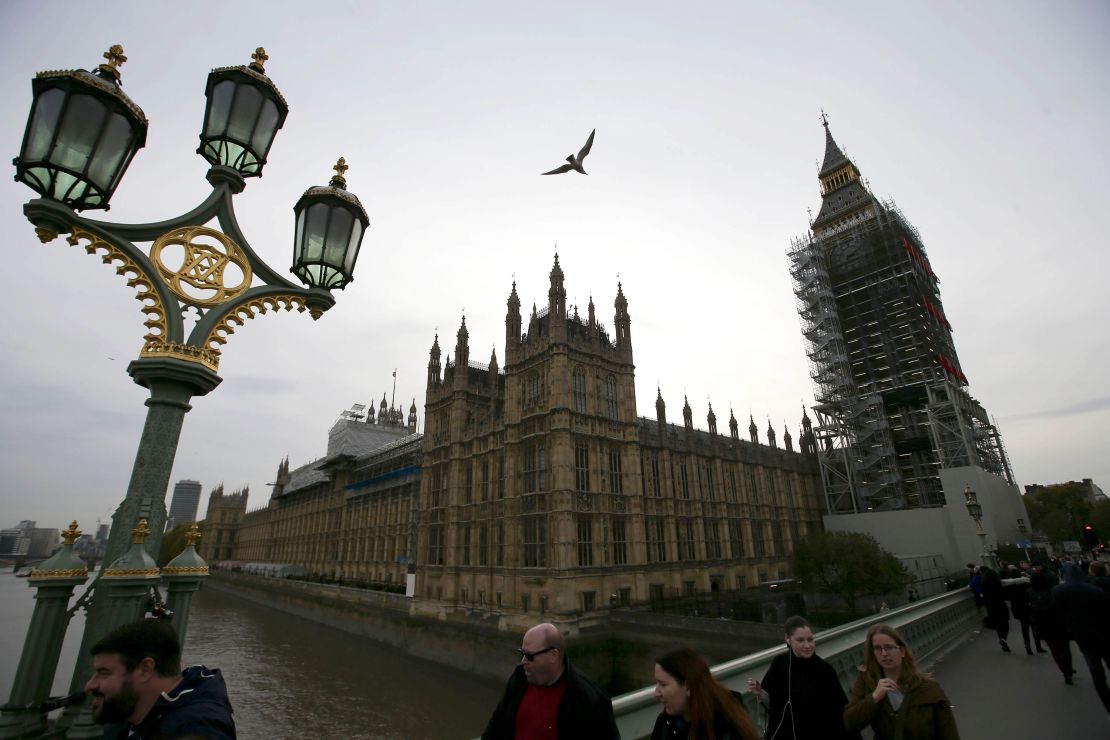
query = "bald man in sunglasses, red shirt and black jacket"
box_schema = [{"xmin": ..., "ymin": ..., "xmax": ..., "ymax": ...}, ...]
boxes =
[{"xmin": 482, "ymin": 622, "xmax": 620, "ymax": 740}]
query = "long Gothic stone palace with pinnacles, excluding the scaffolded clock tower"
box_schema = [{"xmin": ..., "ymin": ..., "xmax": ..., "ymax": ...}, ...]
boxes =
[{"xmin": 208, "ymin": 255, "xmax": 824, "ymax": 616}]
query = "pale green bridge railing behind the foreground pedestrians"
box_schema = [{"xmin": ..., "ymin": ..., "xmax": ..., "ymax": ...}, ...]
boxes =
[{"xmin": 613, "ymin": 589, "xmax": 979, "ymax": 740}]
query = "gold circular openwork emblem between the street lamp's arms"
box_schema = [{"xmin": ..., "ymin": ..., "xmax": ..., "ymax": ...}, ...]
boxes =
[{"xmin": 150, "ymin": 226, "xmax": 251, "ymax": 306}]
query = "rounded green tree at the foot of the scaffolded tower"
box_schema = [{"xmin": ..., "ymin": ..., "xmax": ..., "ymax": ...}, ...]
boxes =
[{"xmin": 794, "ymin": 531, "xmax": 914, "ymax": 615}]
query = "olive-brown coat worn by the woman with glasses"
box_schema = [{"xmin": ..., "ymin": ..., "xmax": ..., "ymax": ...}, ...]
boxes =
[{"xmin": 844, "ymin": 672, "xmax": 960, "ymax": 740}]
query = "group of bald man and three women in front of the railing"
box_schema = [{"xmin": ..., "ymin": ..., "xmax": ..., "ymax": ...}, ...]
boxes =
[{"xmin": 482, "ymin": 617, "xmax": 959, "ymax": 740}]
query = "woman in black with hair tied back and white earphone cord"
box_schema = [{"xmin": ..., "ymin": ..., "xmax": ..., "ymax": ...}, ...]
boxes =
[{"xmin": 748, "ymin": 617, "xmax": 859, "ymax": 740}]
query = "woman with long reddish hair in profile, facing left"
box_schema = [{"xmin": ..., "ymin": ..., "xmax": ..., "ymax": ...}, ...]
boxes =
[{"xmin": 652, "ymin": 648, "xmax": 759, "ymax": 740}]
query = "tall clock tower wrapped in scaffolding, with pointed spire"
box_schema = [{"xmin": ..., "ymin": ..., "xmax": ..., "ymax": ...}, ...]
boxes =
[{"xmin": 789, "ymin": 115, "xmax": 1028, "ymax": 568}]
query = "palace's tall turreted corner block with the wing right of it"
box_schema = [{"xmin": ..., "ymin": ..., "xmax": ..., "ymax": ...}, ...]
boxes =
[{"xmin": 414, "ymin": 256, "xmax": 821, "ymax": 619}]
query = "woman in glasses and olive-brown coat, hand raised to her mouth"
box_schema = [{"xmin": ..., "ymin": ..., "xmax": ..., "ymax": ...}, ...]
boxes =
[{"xmin": 844, "ymin": 625, "xmax": 960, "ymax": 740}]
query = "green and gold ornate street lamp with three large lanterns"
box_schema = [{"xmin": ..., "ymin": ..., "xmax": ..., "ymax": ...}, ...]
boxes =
[{"xmin": 0, "ymin": 45, "xmax": 370, "ymax": 738}]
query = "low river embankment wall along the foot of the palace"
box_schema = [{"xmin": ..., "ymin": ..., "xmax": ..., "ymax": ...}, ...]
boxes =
[{"xmin": 204, "ymin": 571, "xmax": 781, "ymax": 696}]
